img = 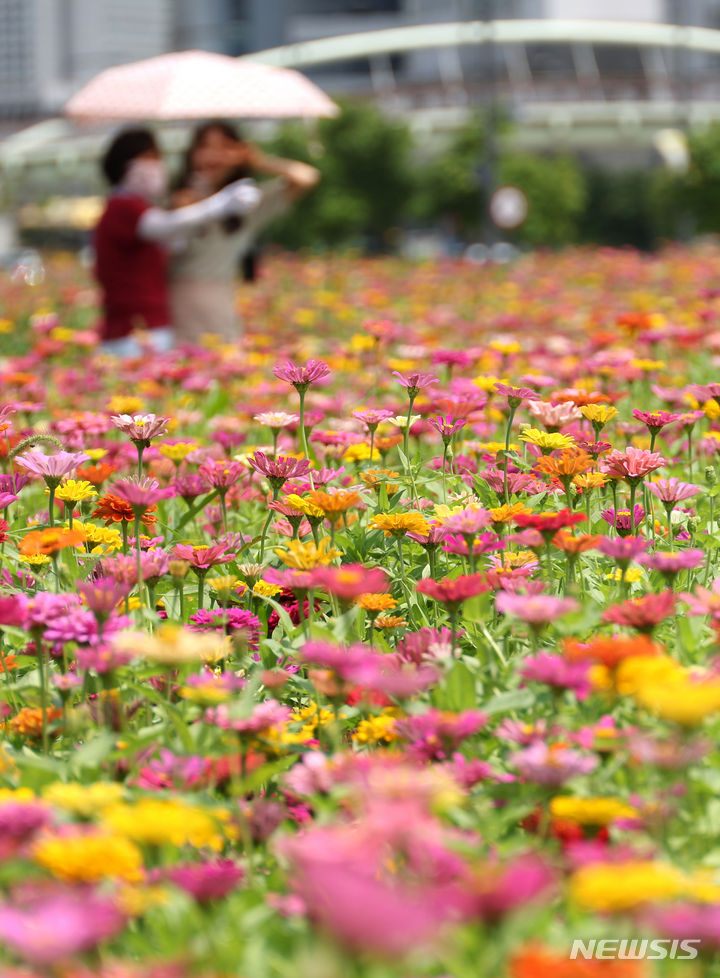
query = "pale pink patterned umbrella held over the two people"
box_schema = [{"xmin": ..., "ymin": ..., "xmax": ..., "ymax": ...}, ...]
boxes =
[{"xmin": 65, "ymin": 51, "xmax": 339, "ymax": 121}]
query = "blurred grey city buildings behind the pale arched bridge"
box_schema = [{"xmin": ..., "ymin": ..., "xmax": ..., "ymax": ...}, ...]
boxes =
[{"xmin": 0, "ymin": 0, "xmax": 720, "ymax": 126}]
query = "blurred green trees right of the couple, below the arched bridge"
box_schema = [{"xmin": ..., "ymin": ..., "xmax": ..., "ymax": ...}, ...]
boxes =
[{"xmin": 268, "ymin": 102, "xmax": 720, "ymax": 250}]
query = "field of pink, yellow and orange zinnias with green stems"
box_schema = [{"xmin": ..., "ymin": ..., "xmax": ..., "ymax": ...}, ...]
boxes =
[{"xmin": 0, "ymin": 247, "xmax": 720, "ymax": 978}]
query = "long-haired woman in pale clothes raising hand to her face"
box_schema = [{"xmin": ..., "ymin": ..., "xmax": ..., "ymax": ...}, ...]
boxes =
[{"xmin": 170, "ymin": 121, "xmax": 320, "ymax": 344}]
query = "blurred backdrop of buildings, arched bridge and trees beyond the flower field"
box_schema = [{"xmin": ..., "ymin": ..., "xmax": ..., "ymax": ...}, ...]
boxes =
[{"xmin": 0, "ymin": 0, "xmax": 720, "ymax": 258}]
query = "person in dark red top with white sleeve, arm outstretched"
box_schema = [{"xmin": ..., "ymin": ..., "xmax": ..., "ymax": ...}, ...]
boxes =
[{"xmin": 94, "ymin": 129, "xmax": 260, "ymax": 356}]
